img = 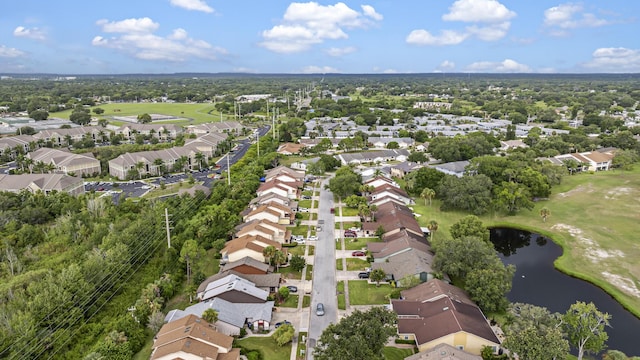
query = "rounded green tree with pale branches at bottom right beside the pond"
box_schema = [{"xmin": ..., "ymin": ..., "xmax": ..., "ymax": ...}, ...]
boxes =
[{"xmin": 562, "ymin": 301, "xmax": 611, "ymax": 360}]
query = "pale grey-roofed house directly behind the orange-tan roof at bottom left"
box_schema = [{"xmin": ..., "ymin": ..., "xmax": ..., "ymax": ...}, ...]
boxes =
[{"xmin": 165, "ymin": 298, "xmax": 275, "ymax": 336}]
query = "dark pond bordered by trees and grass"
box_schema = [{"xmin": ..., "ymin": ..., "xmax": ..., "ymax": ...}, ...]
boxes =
[{"xmin": 491, "ymin": 228, "xmax": 640, "ymax": 356}]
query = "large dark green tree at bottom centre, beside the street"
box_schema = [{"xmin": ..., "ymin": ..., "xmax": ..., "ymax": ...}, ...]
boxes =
[{"xmin": 313, "ymin": 307, "xmax": 397, "ymax": 360}]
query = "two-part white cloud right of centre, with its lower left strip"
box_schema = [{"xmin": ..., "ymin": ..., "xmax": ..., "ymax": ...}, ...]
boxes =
[{"xmin": 406, "ymin": 0, "xmax": 516, "ymax": 45}]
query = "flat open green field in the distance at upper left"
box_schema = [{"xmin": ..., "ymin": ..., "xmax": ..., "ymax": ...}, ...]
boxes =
[{"xmin": 51, "ymin": 103, "xmax": 233, "ymax": 125}]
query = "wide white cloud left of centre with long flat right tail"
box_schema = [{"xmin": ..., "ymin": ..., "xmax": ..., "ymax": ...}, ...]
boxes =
[{"xmin": 91, "ymin": 18, "xmax": 227, "ymax": 62}]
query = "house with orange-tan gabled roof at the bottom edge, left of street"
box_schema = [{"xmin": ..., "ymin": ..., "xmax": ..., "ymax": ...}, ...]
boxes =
[{"xmin": 151, "ymin": 315, "xmax": 240, "ymax": 360}]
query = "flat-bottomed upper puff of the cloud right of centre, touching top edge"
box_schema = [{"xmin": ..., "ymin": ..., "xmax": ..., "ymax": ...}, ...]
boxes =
[{"xmin": 442, "ymin": 0, "xmax": 516, "ymax": 23}]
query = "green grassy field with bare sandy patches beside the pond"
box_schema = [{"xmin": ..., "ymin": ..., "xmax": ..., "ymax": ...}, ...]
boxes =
[{"xmin": 413, "ymin": 167, "xmax": 640, "ymax": 317}]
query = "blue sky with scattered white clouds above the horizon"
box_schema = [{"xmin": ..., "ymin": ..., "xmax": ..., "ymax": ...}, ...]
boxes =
[{"xmin": 0, "ymin": 0, "xmax": 640, "ymax": 74}]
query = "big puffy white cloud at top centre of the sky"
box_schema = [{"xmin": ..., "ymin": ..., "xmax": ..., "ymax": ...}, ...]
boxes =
[{"xmin": 260, "ymin": 2, "xmax": 382, "ymax": 53}]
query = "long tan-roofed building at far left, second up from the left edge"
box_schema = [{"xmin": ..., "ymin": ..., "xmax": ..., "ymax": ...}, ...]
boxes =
[{"xmin": 26, "ymin": 148, "xmax": 101, "ymax": 176}]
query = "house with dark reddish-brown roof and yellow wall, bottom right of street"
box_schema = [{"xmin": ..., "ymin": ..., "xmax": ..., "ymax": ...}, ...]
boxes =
[{"xmin": 391, "ymin": 279, "xmax": 501, "ymax": 355}]
